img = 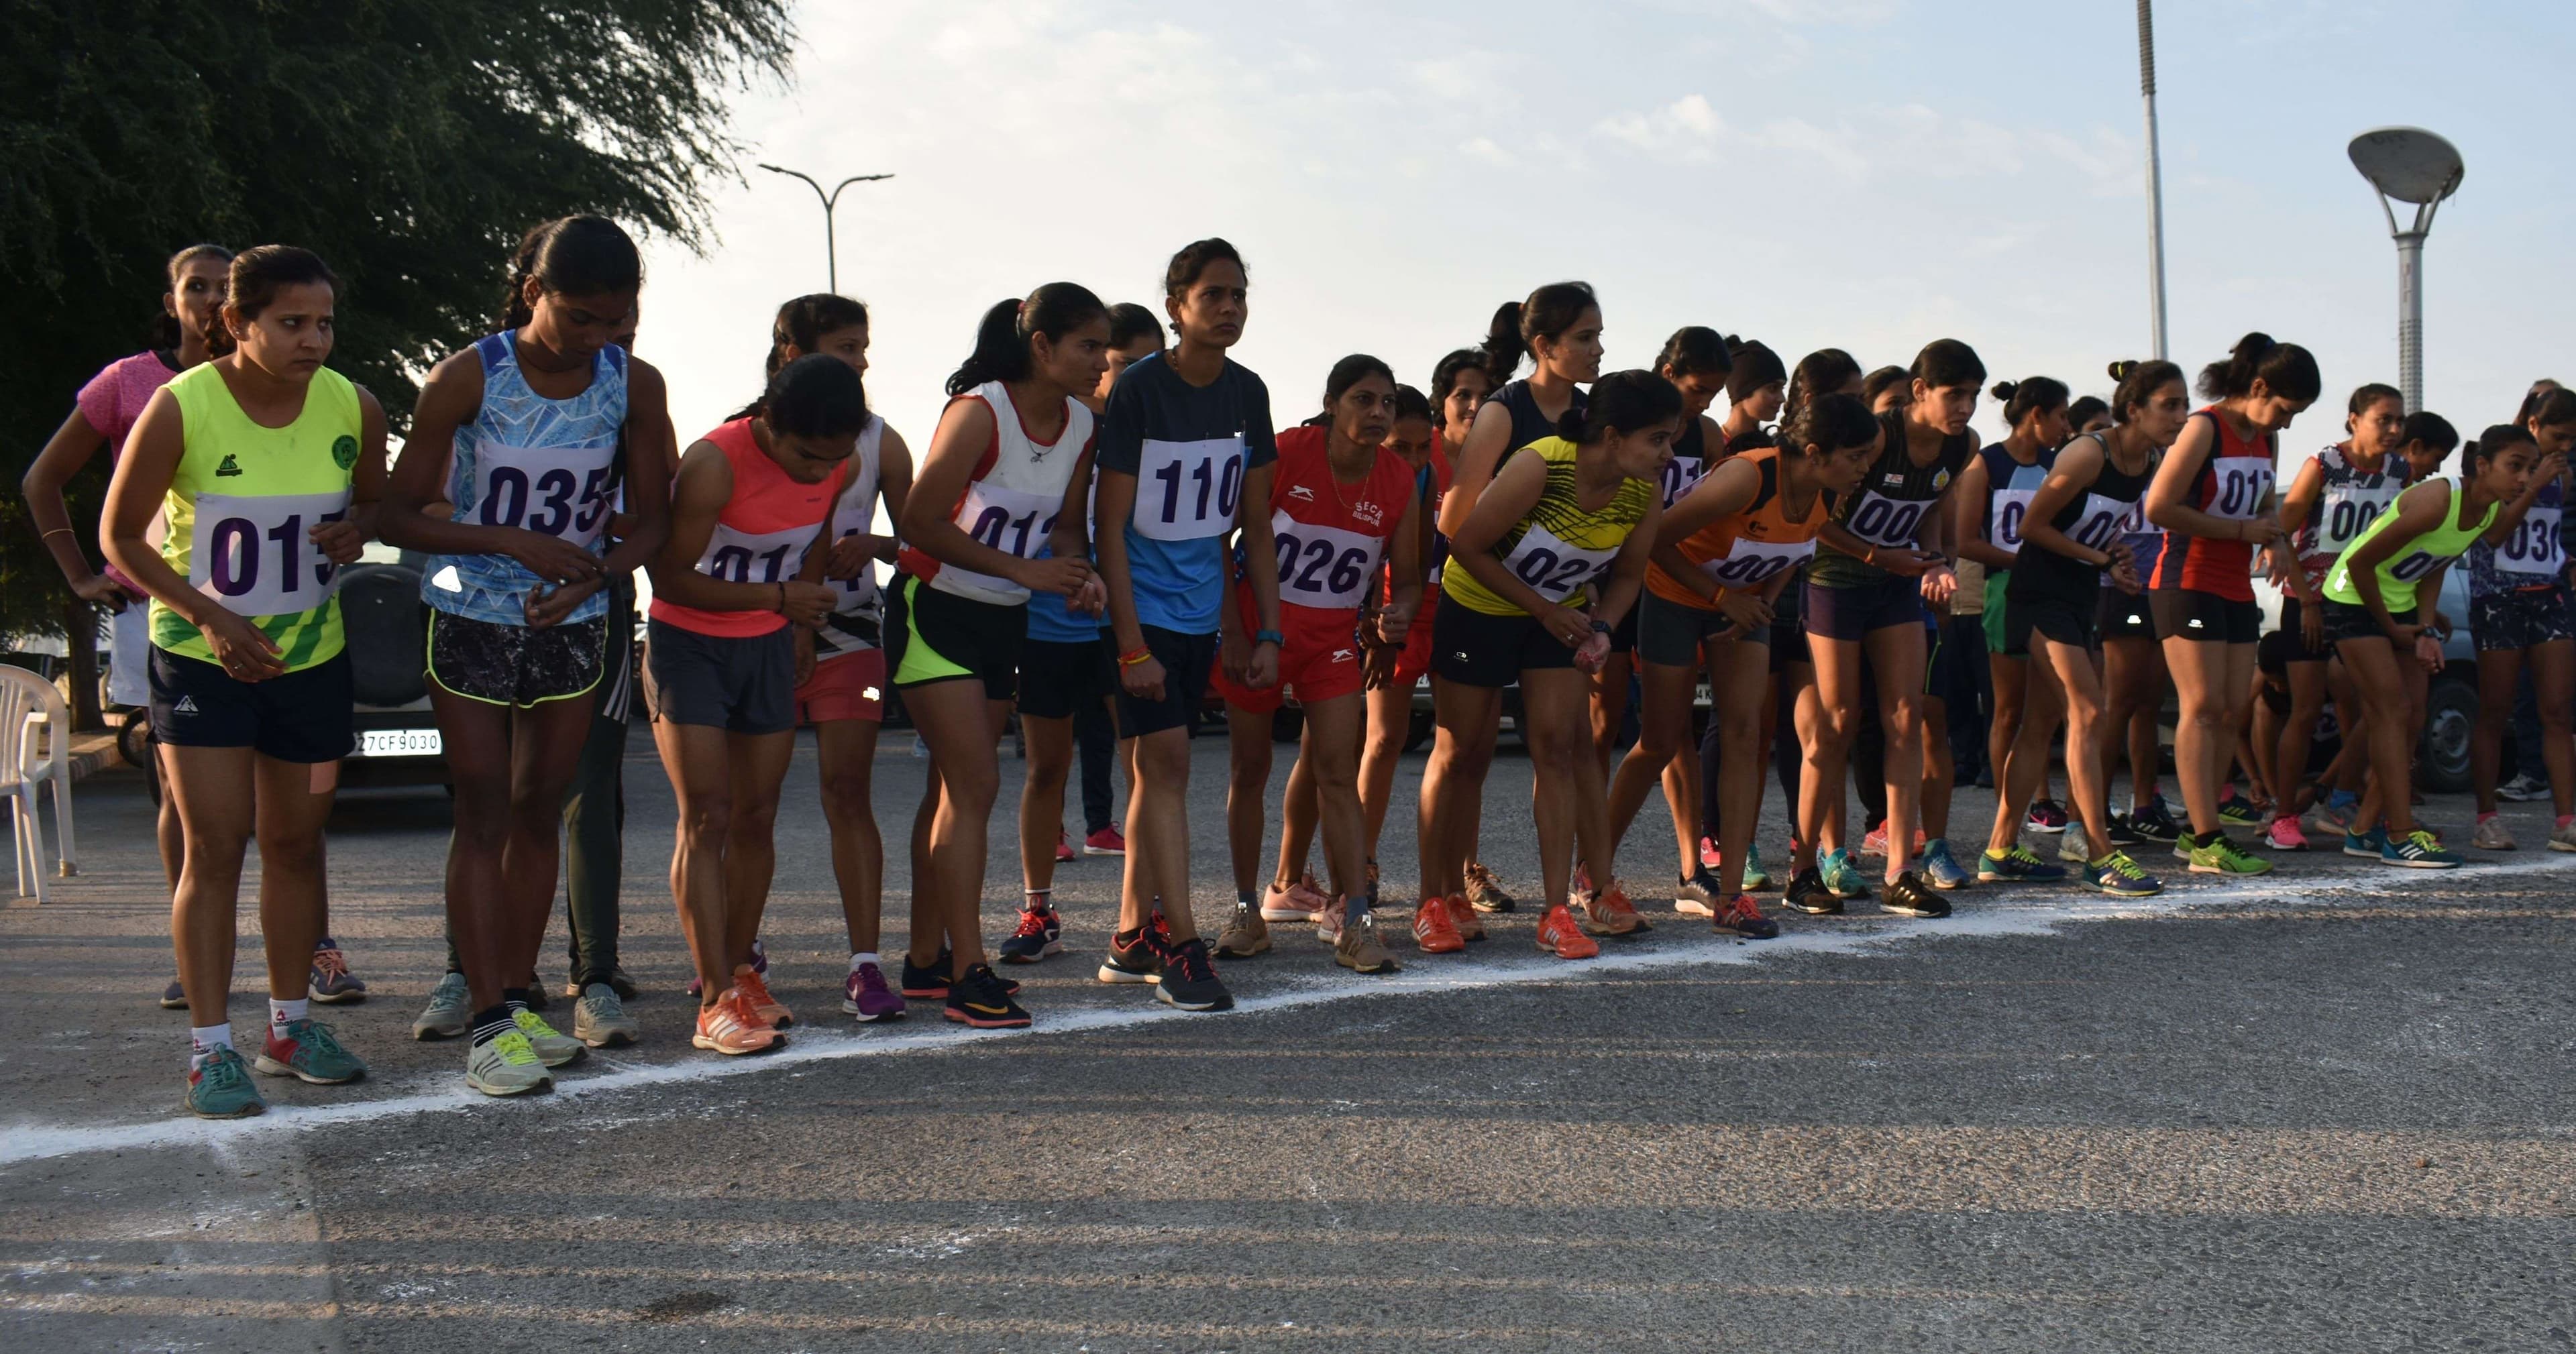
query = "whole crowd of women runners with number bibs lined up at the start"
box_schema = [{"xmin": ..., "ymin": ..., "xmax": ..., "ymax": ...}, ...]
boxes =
[{"xmin": 25, "ymin": 216, "xmax": 2576, "ymax": 1117}]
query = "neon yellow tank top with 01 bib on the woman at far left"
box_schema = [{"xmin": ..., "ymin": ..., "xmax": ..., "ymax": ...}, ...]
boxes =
[{"xmin": 152, "ymin": 363, "xmax": 361, "ymax": 672}]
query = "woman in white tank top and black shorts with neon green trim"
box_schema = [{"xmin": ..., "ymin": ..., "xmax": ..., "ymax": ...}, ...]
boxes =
[{"xmin": 886, "ymin": 283, "xmax": 1110, "ymax": 1029}]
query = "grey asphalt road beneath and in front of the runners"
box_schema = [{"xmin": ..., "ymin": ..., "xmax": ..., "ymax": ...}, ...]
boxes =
[{"xmin": 0, "ymin": 734, "xmax": 2576, "ymax": 1354}]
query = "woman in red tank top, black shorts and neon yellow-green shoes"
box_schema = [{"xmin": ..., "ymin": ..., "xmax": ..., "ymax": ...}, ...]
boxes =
[{"xmin": 2133, "ymin": 335, "xmax": 2318, "ymax": 875}]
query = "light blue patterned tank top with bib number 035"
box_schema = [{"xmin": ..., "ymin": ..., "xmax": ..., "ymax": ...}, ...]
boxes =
[{"xmin": 420, "ymin": 335, "xmax": 626, "ymax": 626}]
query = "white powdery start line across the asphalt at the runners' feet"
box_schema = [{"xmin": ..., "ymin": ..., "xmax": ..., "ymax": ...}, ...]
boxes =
[{"xmin": 0, "ymin": 854, "xmax": 2563, "ymax": 1166}]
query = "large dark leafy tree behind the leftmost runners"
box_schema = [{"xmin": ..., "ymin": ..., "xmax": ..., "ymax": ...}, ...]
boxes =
[{"xmin": 0, "ymin": 0, "xmax": 794, "ymax": 720}]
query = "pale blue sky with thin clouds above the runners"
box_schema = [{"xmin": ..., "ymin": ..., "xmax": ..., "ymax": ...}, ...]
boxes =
[{"xmin": 639, "ymin": 0, "xmax": 2576, "ymax": 461}]
